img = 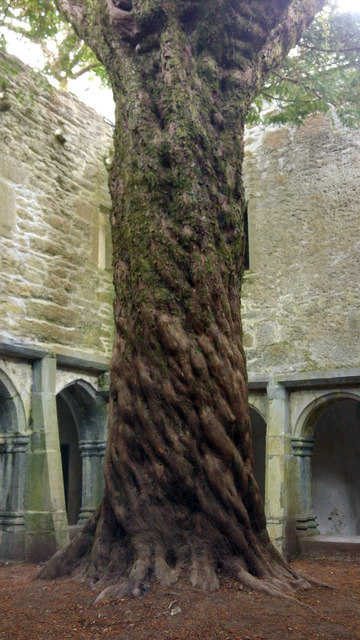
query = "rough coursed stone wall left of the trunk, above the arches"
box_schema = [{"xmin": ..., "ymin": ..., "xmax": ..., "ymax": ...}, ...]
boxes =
[{"xmin": 0, "ymin": 54, "xmax": 113, "ymax": 359}]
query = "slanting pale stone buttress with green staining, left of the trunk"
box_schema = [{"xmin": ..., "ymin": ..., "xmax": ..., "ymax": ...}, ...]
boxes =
[{"xmin": 25, "ymin": 356, "xmax": 69, "ymax": 561}]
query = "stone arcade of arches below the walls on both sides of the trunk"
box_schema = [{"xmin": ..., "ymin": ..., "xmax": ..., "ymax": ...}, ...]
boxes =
[{"xmin": 0, "ymin": 355, "xmax": 360, "ymax": 560}]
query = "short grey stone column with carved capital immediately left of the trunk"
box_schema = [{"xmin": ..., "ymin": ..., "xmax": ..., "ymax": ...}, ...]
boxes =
[{"xmin": 78, "ymin": 440, "xmax": 106, "ymax": 524}]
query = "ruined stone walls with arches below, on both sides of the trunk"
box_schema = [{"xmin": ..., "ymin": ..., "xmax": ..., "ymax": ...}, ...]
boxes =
[{"xmin": 0, "ymin": 54, "xmax": 360, "ymax": 560}]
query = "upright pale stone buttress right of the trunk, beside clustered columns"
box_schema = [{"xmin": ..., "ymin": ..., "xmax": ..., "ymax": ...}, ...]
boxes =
[{"xmin": 265, "ymin": 381, "xmax": 290, "ymax": 552}]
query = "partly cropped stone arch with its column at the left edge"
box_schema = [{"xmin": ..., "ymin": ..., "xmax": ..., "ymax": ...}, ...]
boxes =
[{"xmin": 0, "ymin": 369, "xmax": 29, "ymax": 559}]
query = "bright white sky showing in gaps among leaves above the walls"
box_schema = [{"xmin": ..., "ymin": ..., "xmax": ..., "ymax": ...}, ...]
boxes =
[{"xmin": 1, "ymin": 0, "xmax": 360, "ymax": 122}]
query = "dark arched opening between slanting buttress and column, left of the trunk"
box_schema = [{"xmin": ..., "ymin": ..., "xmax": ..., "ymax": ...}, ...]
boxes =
[{"xmin": 56, "ymin": 393, "xmax": 82, "ymax": 524}]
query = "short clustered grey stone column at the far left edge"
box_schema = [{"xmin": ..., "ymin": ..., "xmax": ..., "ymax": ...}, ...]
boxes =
[{"xmin": 0, "ymin": 433, "xmax": 29, "ymax": 560}]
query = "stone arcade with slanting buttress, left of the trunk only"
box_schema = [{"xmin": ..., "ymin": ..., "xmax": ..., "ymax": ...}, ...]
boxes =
[{"xmin": 0, "ymin": 354, "xmax": 107, "ymax": 561}]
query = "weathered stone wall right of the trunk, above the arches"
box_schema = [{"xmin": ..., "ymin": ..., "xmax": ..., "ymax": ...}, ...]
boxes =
[{"xmin": 243, "ymin": 115, "xmax": 360, "ymax": 375}]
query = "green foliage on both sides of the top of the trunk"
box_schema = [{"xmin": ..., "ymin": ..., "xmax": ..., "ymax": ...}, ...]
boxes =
[{"xmin": 0, "ymin": 0, "xmax": 360, "ymax": 127}]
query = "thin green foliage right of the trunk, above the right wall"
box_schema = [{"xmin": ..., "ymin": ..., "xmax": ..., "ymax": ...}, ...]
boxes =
[{"xmin": 248, "ymin": 1, "xmax": 360, "ymax": 127}]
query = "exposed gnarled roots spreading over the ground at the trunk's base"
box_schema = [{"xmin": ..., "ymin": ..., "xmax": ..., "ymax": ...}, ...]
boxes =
[{"xmin": 38, "ymin": 509, "xmax": 320, "ymax": 606}]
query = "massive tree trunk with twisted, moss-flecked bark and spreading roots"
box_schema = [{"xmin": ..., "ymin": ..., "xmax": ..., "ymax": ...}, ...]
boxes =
[{"xmin": 2, "ymin": 0, "xmax": 323, "ymax": 596}]
